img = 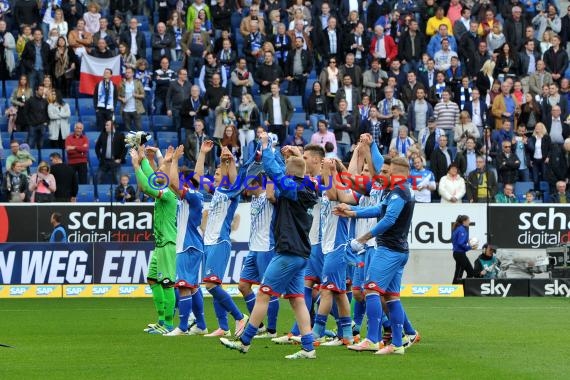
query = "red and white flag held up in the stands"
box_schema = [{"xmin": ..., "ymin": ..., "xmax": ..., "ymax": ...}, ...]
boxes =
[{"xmin": 79, "ymin": 54, "xmax": 121, "ymax": 95}]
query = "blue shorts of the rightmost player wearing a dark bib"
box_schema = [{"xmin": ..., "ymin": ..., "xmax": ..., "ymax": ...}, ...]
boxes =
[{"xmin": 365, "ymin": 247, "xmax": 409, "ymax": 296}]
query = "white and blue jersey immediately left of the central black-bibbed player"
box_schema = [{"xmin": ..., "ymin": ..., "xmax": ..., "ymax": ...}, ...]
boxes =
[{"xmin": 249, "ymin": 193, "xmax": 276, "ymax": 252}]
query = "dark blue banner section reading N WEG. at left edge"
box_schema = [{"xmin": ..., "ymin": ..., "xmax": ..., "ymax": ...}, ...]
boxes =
[{"xmin": 0, "ymin": 243, "xmax": 93, "ymax": 284}]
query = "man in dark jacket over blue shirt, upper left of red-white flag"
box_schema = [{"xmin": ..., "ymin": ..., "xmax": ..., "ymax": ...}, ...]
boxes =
[{"xmin": 20, "ymin": 29, "xmax": 50, "ymax": 88}]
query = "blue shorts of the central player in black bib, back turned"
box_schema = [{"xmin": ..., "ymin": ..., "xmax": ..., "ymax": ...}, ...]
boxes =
[{"xmin": 259, "ymin": 253, "xmax": 308, "ymax": 298}]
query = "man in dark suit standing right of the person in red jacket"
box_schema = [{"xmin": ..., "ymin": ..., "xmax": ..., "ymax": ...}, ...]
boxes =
[{"xmin": 95, "ymin": 120, "xmax": 127, "ymax": 185}]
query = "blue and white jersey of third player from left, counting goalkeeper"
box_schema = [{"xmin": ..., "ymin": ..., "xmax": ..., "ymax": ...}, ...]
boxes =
[{"xmin": 204, "ymin": 189, "xmax": 240, "ymax": 245}]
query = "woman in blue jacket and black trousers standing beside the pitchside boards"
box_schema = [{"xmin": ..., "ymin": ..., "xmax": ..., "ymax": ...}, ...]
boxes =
[{"xmin": 451, "ymin": 215, "xmax": 478, "ymax": 284}]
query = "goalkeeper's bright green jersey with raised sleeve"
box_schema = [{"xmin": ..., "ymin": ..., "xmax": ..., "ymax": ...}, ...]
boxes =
[{"xmin": 136, "ymin": 158, "xmax": 178, "ymax": 247}]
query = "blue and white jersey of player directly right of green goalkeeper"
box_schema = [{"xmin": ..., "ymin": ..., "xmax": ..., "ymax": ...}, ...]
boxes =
[{"xmin": 176, "ymin": 189, "xmax": 204, "ymax": 253}]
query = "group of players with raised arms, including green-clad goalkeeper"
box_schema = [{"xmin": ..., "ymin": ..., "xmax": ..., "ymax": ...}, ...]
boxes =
[{"xmin": 130, "ymin": 134, "xmax": 420, "ymax": 359}]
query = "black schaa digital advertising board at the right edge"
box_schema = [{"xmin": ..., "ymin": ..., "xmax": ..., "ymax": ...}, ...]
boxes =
[{"xmin": 489, "ymin": 204, "xmax": 570, "ymax": 248}]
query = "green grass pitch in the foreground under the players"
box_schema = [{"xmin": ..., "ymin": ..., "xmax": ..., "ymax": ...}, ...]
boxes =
[{"xmin": 0, "ymin": 298, "xmax": 570, "ymax": 380}]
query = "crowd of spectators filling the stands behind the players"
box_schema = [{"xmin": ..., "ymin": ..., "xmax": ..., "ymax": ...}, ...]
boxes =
[{"xmin": 0, "ymin": 0, "xmax": 570, "ymax": 203}]
